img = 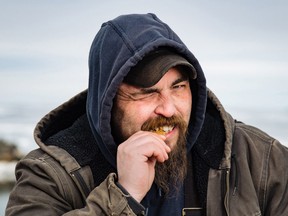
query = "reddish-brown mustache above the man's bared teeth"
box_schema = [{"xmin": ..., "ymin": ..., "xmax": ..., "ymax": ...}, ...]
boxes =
[{"xmin": 141, "ymin": 116, "xmax": 187, "ymax": 131}]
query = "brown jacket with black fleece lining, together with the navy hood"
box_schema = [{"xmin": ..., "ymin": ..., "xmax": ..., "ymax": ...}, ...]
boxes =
[{"xmin": 6, "ymin": 14, "xmax": 288, "ymax": 216}]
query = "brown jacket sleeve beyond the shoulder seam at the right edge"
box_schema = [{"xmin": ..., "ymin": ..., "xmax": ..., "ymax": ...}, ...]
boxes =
[{"xmin": 262, "ymin": 140, "xmax": 288, "ymax": 216}]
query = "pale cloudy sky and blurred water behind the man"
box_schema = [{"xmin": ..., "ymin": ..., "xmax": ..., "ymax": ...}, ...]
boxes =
[{"xmin": 0, "ymin": 0, "xmax": 288, "ymax": 215}]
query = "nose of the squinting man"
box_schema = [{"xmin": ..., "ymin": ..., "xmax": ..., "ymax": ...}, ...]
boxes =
[{"xmin": 155, "ymin": 95, "xmax": 176, "ymax": 118}]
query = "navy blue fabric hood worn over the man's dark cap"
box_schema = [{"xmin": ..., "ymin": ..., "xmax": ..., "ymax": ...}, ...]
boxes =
[{"xmin": 87, "ymin": 14, "xmax": 207, "ymax": 167}]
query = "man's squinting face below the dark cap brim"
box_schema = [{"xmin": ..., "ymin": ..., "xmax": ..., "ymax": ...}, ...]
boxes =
[{"xmin": 112, "ymin": 68, "xmax": 192, "ymax": 149}]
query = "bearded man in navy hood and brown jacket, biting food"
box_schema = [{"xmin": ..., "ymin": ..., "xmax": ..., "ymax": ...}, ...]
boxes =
[{"xmin": 6, "ymin": 14, "xmax": 288, "ymax": 216}]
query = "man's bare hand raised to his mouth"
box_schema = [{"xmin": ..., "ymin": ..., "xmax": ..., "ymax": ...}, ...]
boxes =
[{"xmin": 117, "ymin": 131, "xmax": 171, "ymax": 202}]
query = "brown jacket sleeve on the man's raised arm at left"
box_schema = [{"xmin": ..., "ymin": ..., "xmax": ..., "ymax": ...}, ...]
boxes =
[{"xmin": 5, "ymin": 154, "xmax": 144, "ymax": 216}]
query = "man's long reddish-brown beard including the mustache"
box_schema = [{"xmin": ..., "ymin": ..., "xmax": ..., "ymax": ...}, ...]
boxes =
[{"xmin": 142, "ymin": 117, "xmax": 187, "ymax": 196}]
